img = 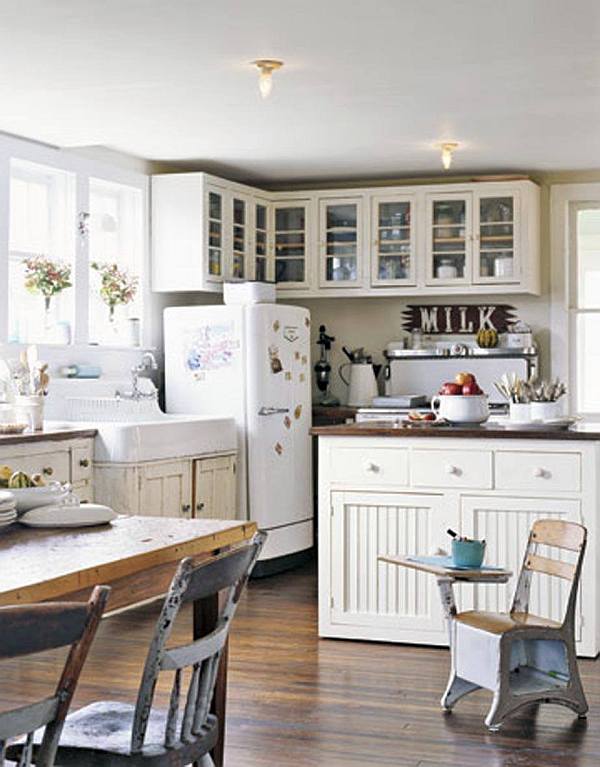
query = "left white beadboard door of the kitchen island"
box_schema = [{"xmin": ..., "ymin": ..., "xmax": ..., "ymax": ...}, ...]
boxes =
[{"xmin": 326, "ymin": 492, "xmax": 453, "ymax": 644}]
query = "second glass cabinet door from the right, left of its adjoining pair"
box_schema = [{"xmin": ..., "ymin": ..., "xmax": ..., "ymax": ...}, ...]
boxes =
[{"xmin": 427, "ymin": 193, "xmax": 472, "ymax": 285}]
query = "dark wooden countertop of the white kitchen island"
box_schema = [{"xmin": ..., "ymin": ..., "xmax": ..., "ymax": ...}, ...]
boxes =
[{"xmin": 310, "ymin": 421, "xmax": 600, "ymax": 442}]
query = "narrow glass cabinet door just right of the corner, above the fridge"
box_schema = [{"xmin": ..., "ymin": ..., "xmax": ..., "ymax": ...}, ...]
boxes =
[{"xmin": 274, "ymin": 201, "xmax": 308, "ymax": 288}]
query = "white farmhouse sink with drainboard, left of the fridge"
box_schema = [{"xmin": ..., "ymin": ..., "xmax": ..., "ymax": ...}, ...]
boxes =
[{"xmin": 51, "ymin": 397, "xmax": 237, "ymax": 463}]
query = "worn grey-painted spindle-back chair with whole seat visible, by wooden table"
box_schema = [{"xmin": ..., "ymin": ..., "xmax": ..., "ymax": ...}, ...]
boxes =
[{"xmin": 9, "ymin": 533, "xmax": 266, "ymax": 767}]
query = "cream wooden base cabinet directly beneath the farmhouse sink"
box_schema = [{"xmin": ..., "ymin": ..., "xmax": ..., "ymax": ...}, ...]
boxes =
[{"xmin": 95, "ymin": 453, "xmax": 238, "ymax": 519}]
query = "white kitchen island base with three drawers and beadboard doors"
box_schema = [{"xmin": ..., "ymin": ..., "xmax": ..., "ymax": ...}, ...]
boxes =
[{"xmin": 319, "ymin": 436, "xmax": 600, "ymax": 657}]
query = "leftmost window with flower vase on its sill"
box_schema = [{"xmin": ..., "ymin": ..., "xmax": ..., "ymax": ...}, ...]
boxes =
[{"xmin": 8, "ymin": 160, "xmax": 75, "ymax": 343}]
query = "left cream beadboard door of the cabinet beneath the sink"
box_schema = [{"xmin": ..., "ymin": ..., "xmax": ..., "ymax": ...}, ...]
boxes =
[{"xmin": 139, "ymin": 459, "xmax": 192, "ymax": 517}]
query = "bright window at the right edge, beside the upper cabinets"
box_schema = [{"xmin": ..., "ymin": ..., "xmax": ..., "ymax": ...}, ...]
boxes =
[{"xmin": 571, "ymin": 203, "xmax": 600, "ymax": 414}]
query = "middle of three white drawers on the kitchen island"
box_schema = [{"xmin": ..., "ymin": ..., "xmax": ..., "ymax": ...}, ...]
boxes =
[{"xmin": 410, "ymin": 450, "xmax": 492, "ymax": 489}]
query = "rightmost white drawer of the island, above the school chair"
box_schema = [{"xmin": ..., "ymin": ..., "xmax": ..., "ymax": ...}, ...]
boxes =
[{"xmin": 496, "ymin": 450, "xmax": 581, "ymax": 493}]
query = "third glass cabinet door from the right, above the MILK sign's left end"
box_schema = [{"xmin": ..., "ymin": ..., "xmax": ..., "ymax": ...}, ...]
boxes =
[{"xmin": 371, "ymin": 195, "xmax": 415, "ymax": 285}]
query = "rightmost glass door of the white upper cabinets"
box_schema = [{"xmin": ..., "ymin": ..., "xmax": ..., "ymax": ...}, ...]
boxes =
[{"xmin": 475, "ymin": 193, "xmax": 519, "ymax": 284}]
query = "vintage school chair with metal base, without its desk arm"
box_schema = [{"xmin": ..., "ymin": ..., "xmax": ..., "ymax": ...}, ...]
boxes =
[{"xmin": 442, "ymin": 519, "xmax": 588, "ymax": 731}]
